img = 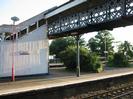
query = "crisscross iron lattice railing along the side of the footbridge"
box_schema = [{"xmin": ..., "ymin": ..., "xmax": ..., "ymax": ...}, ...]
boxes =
[{"xmin": 48, "ymin": 0, "xmax": 133, "ymax": 35}]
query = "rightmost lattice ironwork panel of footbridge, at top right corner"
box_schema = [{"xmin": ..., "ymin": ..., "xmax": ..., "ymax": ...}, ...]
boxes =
[{"xmin": 126, "ymin": 0, "xmax": 133, "ymax": 15}]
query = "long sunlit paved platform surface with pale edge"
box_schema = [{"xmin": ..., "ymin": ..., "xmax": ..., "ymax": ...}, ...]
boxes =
[{"xmin": 0, "ymin": 68, "xmax": 133, "ymax": 96}]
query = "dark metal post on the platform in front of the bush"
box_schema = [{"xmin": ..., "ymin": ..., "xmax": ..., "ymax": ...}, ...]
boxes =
[{"xmin": 76, "ymin": 35, "xmax": 80, "ymax": 77}]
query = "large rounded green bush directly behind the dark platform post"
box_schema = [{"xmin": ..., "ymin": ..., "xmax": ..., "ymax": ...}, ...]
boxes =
[{"xmin": 60, "ymin": 46, "xmax": 103, "ymax": 72}]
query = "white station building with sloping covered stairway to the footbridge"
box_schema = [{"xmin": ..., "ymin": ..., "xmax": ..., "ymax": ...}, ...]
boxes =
[{"xmin": 0, "ymin": 9, "xmax": 55, "ymax": 77}]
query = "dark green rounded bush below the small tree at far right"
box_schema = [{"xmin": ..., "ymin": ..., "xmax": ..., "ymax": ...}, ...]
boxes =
[{"xmin": 108, "ymin": 53, "xmax": 129, "ymax": 67}]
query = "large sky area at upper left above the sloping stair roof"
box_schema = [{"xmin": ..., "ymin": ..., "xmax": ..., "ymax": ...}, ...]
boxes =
[{"xmin": 0, "ymin": 0, "xmax": 68, "ymax": 25}]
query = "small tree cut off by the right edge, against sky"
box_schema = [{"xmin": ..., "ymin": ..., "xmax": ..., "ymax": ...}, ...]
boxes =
[{"xmin": 118, "ymin": 41, "xmax": 133, "ymax": 58}]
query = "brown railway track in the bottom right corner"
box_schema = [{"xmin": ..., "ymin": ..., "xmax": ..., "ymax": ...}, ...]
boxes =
[{"xmin": 81, "ymin": 83, "xmax": 133, "ymax": 99}]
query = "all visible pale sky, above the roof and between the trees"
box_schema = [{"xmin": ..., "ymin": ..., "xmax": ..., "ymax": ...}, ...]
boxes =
[{"xmin": 0, "ymin": 0, "xmax": 133, "ymax": 44}]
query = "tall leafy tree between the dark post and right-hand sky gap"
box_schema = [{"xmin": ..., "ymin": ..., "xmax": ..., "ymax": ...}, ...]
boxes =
[{"xmin": 87, "ymin": 30, "xmax": 114, "ymax": 56}]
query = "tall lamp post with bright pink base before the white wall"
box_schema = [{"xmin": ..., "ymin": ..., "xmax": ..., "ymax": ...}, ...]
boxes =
[{"xmin": 11, "ymin": 16, "xmax": 19, "ymax": 81}]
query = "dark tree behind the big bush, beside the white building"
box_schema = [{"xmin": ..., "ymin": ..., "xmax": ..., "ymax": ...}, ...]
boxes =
[{"xmin": 50, "ymin": 37, "xmax": 85, "ymax": 57}]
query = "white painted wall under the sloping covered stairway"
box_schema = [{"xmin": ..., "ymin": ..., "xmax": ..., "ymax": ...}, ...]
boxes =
[{"xmin": 0, "ymin": 25, "xmax": 49, "ymax": 77}]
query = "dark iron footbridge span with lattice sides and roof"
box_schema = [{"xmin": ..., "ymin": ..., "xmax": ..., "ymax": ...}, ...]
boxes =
[{"xmin": 46, "ymin": 0, "xmax": 133, "ymax": 38}]
